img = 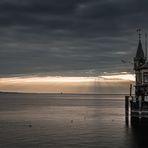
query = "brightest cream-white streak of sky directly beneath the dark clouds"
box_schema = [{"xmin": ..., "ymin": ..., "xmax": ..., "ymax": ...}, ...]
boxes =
[{"xmin": 0, "ymin": 73, "xmax": 135, "ymax": 83}]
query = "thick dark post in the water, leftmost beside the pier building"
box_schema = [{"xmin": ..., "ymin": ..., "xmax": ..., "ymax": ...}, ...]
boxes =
[{"xmin": 125, "ymin": 96, "xmax": 129, "ymax": 126}]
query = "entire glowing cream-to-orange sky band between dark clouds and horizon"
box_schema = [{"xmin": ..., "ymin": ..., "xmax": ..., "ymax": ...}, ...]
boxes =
[{"xmin": 0, "ymin": 73, "xmax": 134, "ymax": 93}]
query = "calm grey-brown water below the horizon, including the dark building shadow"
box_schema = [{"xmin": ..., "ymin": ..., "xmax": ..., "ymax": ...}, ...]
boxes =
[{"xmin": 0, "ymin": 94, "xmax": 148, "ymax": 148}]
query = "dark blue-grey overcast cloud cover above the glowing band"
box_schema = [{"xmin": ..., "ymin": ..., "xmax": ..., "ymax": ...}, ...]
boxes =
[{"xmin": 0, "ymin": 0, "xmax": 148, "ymax": 77}]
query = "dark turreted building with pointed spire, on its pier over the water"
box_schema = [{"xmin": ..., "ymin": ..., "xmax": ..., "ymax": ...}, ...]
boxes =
[{"xmin": 126, "ymin": 29, "xmax": 148, "ymax": 118}]
